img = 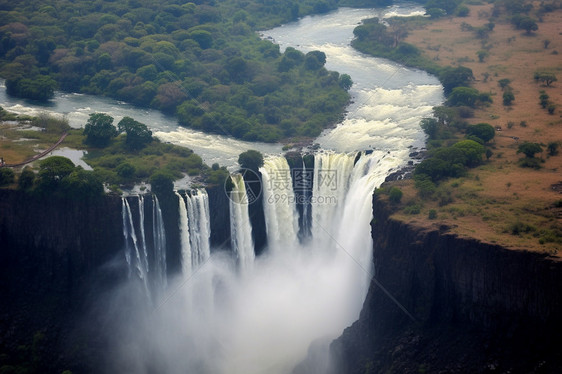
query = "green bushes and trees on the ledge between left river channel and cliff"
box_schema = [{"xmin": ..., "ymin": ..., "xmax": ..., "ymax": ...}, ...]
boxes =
[{"xmin": 0, "ymin": 110, "xmax": 228, "ymax": 194}]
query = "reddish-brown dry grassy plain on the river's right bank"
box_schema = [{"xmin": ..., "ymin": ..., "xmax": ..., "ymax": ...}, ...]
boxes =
[{"xmin": 390, "ymin": 3, "xmax": 562, "ymax": 255}]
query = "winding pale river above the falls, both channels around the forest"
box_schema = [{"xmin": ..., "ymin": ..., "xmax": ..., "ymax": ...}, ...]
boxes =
[{"xmin": 0, "ymin": 4, "xmax": 443, "ymax": 168}]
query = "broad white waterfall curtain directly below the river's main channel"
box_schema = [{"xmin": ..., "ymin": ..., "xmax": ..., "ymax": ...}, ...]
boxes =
[{"xmin": 311, "ymin": 153, "xmax": 356, "ymax": 248}]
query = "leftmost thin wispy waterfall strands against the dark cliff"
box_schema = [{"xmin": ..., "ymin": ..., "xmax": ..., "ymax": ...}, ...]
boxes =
[{"xmin": 121, "ymin": 197, "xmax": 150, "ymax": 297}]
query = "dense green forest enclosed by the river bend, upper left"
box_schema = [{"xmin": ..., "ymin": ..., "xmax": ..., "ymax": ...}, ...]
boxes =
[{"xmin": 0, "ymin": 0, "xmax": 372, "ymax": 142}]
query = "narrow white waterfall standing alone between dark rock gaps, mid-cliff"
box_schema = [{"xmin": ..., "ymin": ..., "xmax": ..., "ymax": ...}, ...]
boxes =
[{"xmin": 230, "ymin": 174, "xmax": 256, "ymax": 272}]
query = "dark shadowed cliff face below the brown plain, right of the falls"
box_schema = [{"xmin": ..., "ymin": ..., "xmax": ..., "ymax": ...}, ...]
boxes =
[{"xmin": 331, "ymin": 198, "xmax": 562, "ymax": 373}]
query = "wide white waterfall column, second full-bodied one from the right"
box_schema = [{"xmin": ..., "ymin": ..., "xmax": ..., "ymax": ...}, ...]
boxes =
[{"xmin": 260, "ymin": 157, "xmax": 299, "ymax": 251}]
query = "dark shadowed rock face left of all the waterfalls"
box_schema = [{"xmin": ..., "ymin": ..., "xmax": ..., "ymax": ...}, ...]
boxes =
[{"xmin": 0, "ymin": 190, "xmax": 126, "ymax": 373}]
